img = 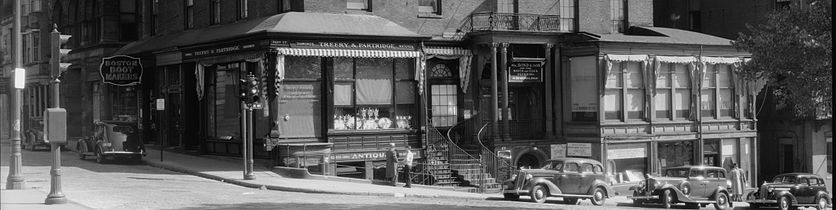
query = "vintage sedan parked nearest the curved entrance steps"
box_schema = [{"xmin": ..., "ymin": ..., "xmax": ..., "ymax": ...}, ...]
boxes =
[{"xmin": 502, "ymin": 158, "xmax": 615, "ymax": 206}]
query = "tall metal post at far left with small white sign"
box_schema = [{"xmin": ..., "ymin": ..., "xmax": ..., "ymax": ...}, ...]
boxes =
[{"xmin": 6, "ymin": 0, "xmax": 25, "ymax": 190}]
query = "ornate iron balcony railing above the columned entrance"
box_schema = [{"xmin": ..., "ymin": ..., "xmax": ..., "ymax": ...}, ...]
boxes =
[{"xmin": 462, "ymin": 12, "xmax": 560, "ymax": 33}]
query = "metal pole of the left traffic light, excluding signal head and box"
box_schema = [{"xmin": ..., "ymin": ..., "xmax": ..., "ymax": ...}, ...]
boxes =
[{"xmin": 44, "ymin": 76, "xmax": 67, "ymax": 204}]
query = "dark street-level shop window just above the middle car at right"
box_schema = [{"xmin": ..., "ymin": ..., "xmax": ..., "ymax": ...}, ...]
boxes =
[{"xmin": 657, "ymin": 141, "xmax": 696, "ymax": 169}]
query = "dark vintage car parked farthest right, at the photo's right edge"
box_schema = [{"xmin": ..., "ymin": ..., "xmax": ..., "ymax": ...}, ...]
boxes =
[{"xmin": 745, "ymin": 173, "xmax": 833, "ymax": 210}]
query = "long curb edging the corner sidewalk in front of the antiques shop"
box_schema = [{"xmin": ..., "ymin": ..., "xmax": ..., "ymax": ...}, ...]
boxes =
[{"xmin": 143, "ymin": 160, "xmax": 486, "ymax": 200}]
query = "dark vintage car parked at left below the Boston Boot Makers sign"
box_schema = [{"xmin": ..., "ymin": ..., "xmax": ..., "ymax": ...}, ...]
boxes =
[{"xmin": 76, "ymin": 121, "xmax": 147, "ymax": 163}]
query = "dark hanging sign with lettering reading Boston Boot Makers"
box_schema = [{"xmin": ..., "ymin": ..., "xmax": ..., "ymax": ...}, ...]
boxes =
[{"xmin": 99, "ymin": 55, "xmax": 142, "ymax": 86}]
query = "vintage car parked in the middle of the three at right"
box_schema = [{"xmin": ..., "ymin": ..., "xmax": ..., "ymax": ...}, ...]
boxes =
[{"xmin": 627, "ymin": 166, "xmax": 732, "ymax": 210}]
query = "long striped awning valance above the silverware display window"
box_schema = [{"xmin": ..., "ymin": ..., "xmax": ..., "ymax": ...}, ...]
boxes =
[{"xmin": 276, "ymin": 48, "xmax": 421, "ymax": 58}]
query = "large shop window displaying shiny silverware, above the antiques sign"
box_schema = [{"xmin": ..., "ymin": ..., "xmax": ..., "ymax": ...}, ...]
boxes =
[{"xmin": 332, "ymin": 57, "xmax": 417, "ymax": 130}]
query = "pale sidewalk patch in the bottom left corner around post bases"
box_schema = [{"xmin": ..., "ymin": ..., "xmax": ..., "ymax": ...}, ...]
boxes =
[{"xmin": 0, "ymin": 189, "xmax": 93, "ymax": 210}]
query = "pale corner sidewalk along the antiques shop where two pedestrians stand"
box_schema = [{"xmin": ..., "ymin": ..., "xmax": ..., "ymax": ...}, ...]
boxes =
[{"xmin": 142, "ymin": 148, "xmax": 501, "ymax": 200}]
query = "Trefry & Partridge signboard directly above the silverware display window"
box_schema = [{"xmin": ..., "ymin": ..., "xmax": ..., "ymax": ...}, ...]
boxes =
[{"xmin": 290, "ymin": 41, "xmax": 416, "ymax": 51}]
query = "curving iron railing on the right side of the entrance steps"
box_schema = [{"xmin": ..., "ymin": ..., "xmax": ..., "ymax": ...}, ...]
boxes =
[{"xmin": 477, "ymin": 123, "xmax": 515, "ymax": 186}]
